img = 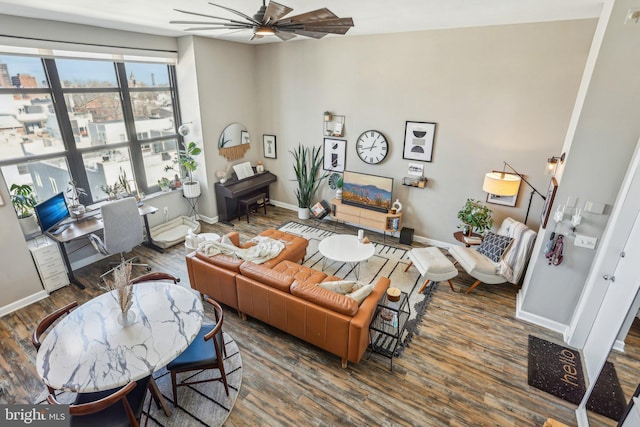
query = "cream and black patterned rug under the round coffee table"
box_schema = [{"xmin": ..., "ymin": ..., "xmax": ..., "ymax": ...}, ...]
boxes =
[{"xmin": 279, "ymin": 222, "xmax": 437, "ymax": 356}]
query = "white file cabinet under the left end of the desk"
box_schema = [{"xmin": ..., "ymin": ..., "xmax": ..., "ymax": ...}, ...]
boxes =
[{"xmin": 29, "ymin": 236, "xmax": 69, "ymax": 292}]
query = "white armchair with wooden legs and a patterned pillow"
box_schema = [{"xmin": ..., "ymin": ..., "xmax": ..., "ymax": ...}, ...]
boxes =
[{"xmin": 449, "ymin": 217, "xmax": 537, "ymax": 293}]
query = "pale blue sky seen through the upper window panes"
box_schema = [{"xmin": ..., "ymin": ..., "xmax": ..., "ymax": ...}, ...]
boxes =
[{"xmin": 0, "ymin": 55, "xmax": 169, "ymax": 86}]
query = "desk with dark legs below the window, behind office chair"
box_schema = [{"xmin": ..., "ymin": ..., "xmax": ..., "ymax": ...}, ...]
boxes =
[{"xmin": 46, "ymin": 205, "xmax": 164, "ymax": 289}]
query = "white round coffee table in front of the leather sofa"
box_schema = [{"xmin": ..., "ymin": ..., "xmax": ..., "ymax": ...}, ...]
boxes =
[{"xmin": 318, "ymin": 234, "xmax": 376, "ymax": 279}]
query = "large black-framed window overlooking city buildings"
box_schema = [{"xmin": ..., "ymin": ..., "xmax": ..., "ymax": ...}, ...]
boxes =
[{"xmin": 0, "ymin": 54, "xmax": 180, "ymax": 204}]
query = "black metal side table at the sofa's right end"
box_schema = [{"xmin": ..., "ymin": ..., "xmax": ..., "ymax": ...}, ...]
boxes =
[{"xmin": 369, "ymin": 292, "xmax": 411, "ymax": 371}]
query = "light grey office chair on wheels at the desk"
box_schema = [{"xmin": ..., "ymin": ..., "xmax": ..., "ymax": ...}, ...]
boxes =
[{"xmin": 89, "ymin": 197, "xmax": 151, "ymax": 281}]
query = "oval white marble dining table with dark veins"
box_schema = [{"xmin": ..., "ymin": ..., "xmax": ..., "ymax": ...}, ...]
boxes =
[{"xmin": 36, "ymin": 282, "xmax": 203, "ymax": 402}]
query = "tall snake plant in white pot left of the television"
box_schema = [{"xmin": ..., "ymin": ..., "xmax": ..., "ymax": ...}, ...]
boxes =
[{"xmin": 289, "ymin": 144, "xmax": 327, "ymax": 219}]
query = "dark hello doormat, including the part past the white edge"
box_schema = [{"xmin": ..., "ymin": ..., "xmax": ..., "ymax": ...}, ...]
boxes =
[{"xmin": 528, "ymin": 335, "xmax": 627, "ymax": 421}]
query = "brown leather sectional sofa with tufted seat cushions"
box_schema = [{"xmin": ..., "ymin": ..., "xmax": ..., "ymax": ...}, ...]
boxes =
[{"xmin": 187, "ymin": 230, "xmax": 390, "ymax": 367}]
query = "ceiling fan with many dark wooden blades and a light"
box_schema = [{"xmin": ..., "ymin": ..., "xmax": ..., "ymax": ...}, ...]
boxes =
[{"xmin": 170, "ymin": 0, "xmax": 353, "ymax": 41}]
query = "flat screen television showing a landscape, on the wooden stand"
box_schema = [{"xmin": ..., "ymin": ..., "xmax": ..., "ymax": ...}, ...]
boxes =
[{"xmin": 342, "ymin": 171, "xmax": 393, "ymax": 212}]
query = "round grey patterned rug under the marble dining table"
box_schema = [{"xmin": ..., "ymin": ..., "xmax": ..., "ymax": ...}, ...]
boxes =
[{"xmin": 38, "ymin": 332, "xmax": 242, "ymax": 427}]
